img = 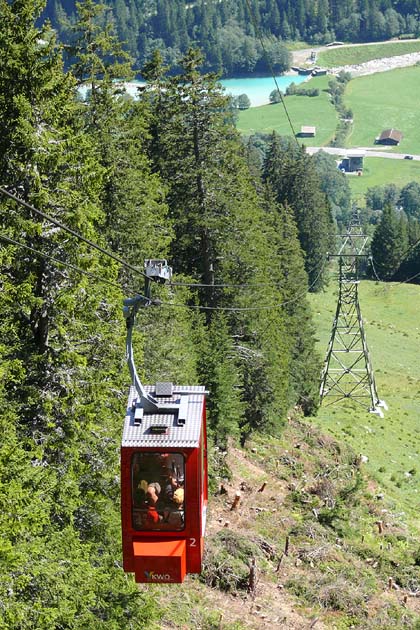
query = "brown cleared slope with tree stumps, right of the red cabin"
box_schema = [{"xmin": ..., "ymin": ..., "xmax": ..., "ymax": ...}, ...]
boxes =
[{"xmin": 147, "ymin": 416, "xmax": 420, "ymax": 630}]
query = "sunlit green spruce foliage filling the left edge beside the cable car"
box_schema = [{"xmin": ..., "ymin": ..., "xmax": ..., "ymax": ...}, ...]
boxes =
[{"xmin": 0, "ymin": 0, "xmax": 163, "ymax": 630}]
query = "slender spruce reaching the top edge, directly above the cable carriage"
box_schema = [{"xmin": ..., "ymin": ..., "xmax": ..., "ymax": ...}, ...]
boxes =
[{"xmin": 71, "ymin": 0, "xmax": 171, "ymax": 282}]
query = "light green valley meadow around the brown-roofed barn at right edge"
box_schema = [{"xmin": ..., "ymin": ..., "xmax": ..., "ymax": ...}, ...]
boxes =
[{"xmin": 344, "ymin": 66, "xmax": 420, "ymax": 153}]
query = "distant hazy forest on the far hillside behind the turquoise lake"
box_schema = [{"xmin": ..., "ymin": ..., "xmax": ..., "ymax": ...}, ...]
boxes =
[{"xmin": 43, "ymin": 0, "xmax": 420, "ymax": 76}]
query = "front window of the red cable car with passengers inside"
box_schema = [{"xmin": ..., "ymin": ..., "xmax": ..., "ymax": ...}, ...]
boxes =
[{"xmin": 131, "ymin": 453, "xmax": 185, "ymax": 531}]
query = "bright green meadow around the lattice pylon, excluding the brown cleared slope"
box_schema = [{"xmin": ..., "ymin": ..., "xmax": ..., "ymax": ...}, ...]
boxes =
[{"xmin": 310, "ymin": 280, "xmax": 420, "ymax": 523}]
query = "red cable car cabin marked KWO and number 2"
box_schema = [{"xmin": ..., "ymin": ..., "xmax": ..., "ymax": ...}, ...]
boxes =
[{"xmin": 121, "ymin": 383, "xmax": 207, "ymax": 583}]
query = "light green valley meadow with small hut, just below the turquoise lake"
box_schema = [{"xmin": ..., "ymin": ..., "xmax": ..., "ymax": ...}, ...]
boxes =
[{"xmin": 237, "ymin": 77, "xmax": 337, "ymax": 146}]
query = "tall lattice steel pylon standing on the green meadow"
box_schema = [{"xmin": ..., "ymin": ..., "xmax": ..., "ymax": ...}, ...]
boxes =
[{"xmin": 320, "ymin": 210, "xmax": 387, "ymax": 417}]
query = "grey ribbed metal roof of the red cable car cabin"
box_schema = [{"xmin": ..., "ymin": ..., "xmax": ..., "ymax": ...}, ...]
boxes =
[{"xmin": 122, "ymin": 383, "xmax": 206, "ymax": 449}]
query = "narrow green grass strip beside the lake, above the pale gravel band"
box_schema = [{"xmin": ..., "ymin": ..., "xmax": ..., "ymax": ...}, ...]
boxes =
[{"xmin": 317, "ymin": 40, "xmax": 420, "ymax": 68}]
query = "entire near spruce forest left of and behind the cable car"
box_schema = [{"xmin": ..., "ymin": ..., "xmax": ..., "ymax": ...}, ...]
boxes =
[{"xmin": 0, "ymin": 0, "xmax": 340, "ymax": 630}]
